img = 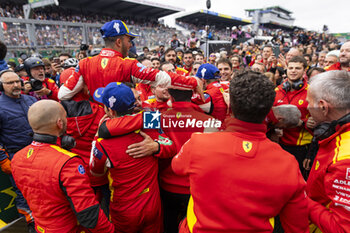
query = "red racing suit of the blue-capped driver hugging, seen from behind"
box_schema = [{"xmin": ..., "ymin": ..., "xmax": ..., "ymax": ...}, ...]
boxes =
[{"xmin": 90, "ymin": 118, "xmax": 176, "ymax": 233}]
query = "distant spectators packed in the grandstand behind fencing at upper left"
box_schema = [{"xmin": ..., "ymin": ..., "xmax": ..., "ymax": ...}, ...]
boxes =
[{"xmin": 0, "ymin": 3, "xmax": 185, "ymax": 47}]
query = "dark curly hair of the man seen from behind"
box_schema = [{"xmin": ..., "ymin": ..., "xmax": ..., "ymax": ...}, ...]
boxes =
[{"xmin": 230, "ymin": 71, "xmax": 276, "ymax": 123}]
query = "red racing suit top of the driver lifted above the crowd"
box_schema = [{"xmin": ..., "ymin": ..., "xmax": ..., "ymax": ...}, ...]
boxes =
[{"xmin": 59, "ymin": 48, "xmax": 197, "ymax": 100}]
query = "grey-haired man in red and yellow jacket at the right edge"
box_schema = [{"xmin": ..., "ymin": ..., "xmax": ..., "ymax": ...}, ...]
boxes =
[{"xmin": 306, "ymin": 71, "xmax": 350, "ymax": 232}]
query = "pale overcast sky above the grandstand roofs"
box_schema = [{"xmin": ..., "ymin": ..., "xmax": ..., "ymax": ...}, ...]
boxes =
[{"xmin": 154, "ymin": 0, "xmax": 350, "ymax": 33}]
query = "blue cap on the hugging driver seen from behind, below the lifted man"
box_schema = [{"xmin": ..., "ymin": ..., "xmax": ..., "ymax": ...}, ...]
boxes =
[{"xmin": 94, "ymin": 82, "xmax": 136, "ymax": 112}]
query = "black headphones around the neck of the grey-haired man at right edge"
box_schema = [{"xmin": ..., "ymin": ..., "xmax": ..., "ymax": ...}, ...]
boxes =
[{"xmin": 314, "ymin": 113, "xmax": 350, "ymax": 140}]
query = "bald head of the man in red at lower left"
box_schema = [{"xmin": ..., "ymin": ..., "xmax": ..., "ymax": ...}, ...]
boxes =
[{"xmin": 28, "ymin": 100, "xmax": 67, "ymax": 136}]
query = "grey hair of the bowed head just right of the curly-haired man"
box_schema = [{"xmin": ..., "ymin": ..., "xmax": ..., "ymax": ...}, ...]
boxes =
[{"xmin": 273, "ymin": 104, "xmax": 301, "ymax": 126}]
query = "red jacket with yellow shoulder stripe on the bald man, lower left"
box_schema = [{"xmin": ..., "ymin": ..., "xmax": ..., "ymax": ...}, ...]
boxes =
[{"xmin": 11, "ymin": 141, "xmax": 114, "ymax": 233}]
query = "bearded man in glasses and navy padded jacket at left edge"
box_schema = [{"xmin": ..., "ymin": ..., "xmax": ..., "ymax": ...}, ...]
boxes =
[{"xmin": 0, "ymin": 70, "xmax": 36, "ymax": 233}]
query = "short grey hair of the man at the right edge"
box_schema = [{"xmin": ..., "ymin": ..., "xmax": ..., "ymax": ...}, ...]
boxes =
[{"xmin": 309, "ymin": 70, "xmax": 350, "ymax": 110}]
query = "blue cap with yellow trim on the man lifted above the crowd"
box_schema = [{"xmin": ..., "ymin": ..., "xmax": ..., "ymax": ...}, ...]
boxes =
[{"xmin": 100, "ymin": 20, "xmax": 139, "ymax": 38}]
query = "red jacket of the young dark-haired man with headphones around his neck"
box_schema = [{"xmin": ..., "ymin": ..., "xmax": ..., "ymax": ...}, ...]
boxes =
[{"xmin": 271, "ymin": 81, "xmax": 312, "ymax": 146}]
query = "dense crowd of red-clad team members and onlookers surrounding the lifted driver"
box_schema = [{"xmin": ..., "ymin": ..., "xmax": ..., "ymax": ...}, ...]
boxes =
[{"xmin": 0, "ymin": 7, "xmax": 350, "ymax": 233}]
